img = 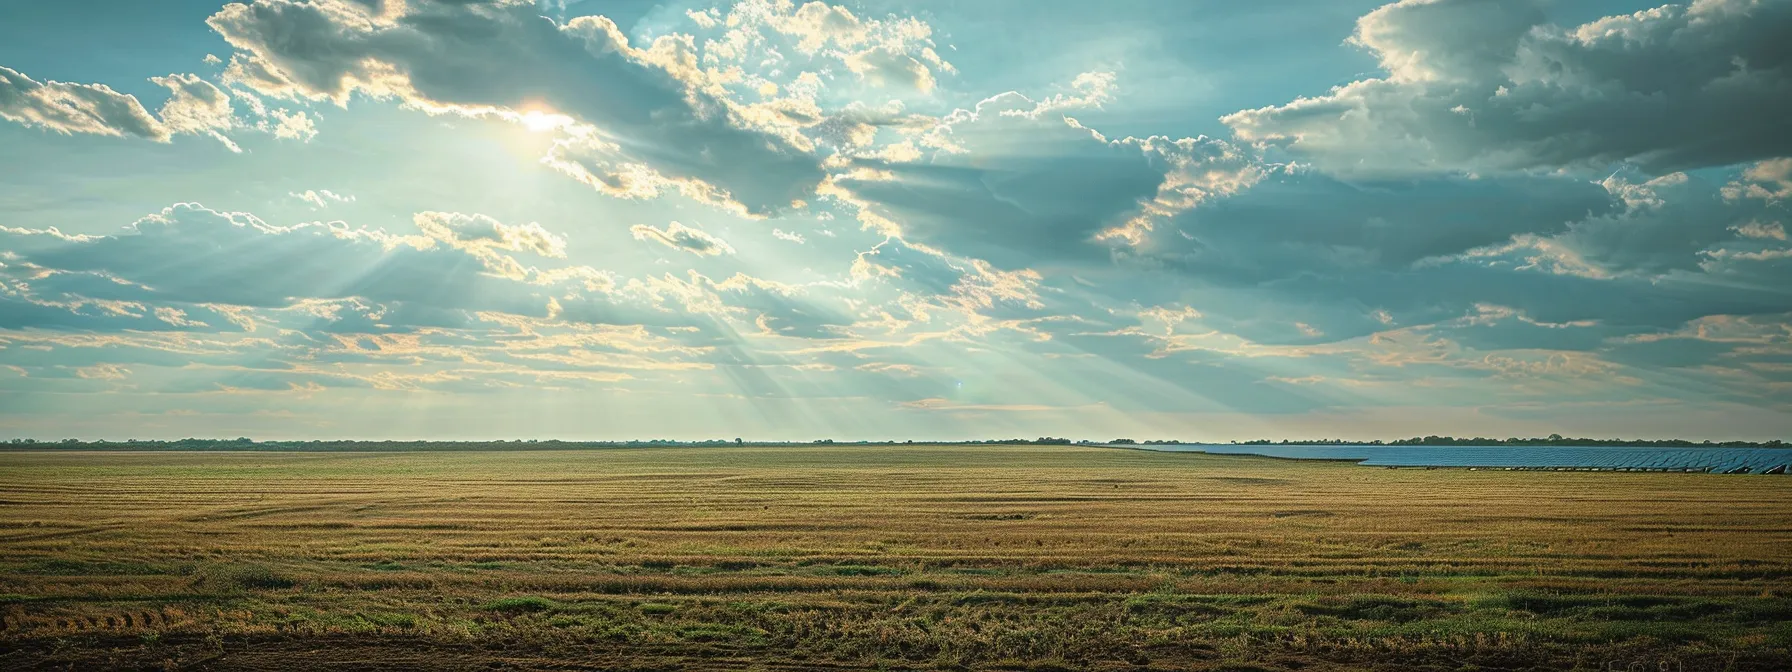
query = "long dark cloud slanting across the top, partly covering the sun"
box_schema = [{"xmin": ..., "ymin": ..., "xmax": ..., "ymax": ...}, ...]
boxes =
[{"xmin": 208, "ymin": 0, "xmax": 823, "ymax": 215}]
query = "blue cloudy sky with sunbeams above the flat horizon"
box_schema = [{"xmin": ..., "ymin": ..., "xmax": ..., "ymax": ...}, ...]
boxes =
[{"xmin": 0, "ymin": 0, "xmax": 1792, "ymax": 441}]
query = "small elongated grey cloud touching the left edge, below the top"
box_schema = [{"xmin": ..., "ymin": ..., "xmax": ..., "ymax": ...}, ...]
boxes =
[{"xmin": 0, "ymin": 66, "xmax": 170, "ymax": 142}]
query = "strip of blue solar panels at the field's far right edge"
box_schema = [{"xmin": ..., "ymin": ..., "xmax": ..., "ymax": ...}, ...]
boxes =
[{"xmin": 1127, "ymin": 444, "xmax": 1792, "ymax": 473}]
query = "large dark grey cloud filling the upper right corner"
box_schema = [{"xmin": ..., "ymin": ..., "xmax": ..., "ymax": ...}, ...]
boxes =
[{"xmin": 1224, "ymin": 0, "xmax": 1792, "ymax": 174}]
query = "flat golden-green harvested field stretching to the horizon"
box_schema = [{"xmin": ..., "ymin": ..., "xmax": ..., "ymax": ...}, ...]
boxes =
[{"xmin": 0, "ymin": 446, "xmax": 1792, "ymax": 670}]
